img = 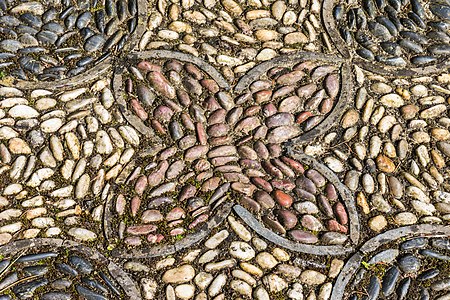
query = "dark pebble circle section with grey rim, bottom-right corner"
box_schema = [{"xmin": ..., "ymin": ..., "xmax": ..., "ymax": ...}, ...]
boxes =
[{"xmin": 332, "ymin": 227, "xmax": 450, "ymax": 300}]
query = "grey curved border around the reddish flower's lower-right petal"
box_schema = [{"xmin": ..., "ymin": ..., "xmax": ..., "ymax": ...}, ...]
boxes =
[{"xmin": 233, "ymin": 152, "xmax": 360, "ymax": 255}]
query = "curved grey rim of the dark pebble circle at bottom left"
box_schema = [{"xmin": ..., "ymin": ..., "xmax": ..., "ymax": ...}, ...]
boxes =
[{"xmin": 0, "ymin": 238, "xmax": 142, "ymax": 300}]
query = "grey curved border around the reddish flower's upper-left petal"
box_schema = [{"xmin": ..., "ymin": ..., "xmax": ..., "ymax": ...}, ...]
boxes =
[{"xmin": 112, "ymin": 50, "xmax": 229, "ymax": 143}]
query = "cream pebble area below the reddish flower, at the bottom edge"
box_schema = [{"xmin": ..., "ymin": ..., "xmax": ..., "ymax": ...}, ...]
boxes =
[{"xmin": 130, "ymin": 215, "xmax": 344, "ymax": 300}]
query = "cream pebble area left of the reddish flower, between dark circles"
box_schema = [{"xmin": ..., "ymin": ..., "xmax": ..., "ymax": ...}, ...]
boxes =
[{"xmin": 0, "ymin": 80, "xmax": 139, "ymax": 244}]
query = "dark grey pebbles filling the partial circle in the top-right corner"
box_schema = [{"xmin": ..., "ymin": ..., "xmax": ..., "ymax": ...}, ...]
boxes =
[{"xmin": 324, "ymin": 0, "xmax": 450, "ymax": 68}]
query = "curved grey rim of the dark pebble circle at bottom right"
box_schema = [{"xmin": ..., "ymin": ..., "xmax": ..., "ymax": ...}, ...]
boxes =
[{"xmin": 330, "ymin": 224, "xmax": 450, "ymax": 300}]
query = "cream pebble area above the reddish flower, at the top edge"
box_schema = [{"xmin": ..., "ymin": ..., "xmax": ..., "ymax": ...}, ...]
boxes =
[{"xmin": 139, "ymin": 0, "xmax": 332, "ymax": 78}]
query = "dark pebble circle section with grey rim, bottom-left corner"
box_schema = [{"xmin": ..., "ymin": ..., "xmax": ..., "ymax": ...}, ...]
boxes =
[{"xmin": 0, "ymin": 239, "xmax": 140, "ymax": 300}]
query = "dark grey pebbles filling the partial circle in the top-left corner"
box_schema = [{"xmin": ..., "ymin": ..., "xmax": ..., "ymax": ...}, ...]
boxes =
[{"xmin": 0, "ymin": 0, "xmax": 138, "ymax": 81}]
